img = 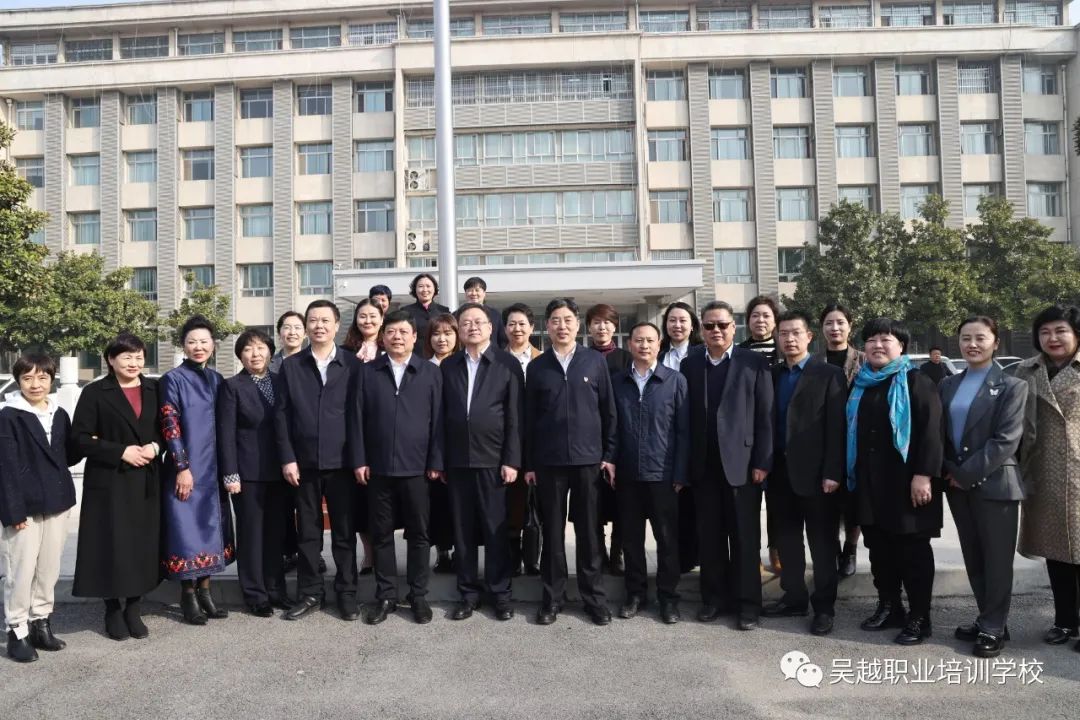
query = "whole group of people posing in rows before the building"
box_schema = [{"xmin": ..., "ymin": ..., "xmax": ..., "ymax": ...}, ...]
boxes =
[{"xmin": 0, "ymin": 273, "xmax": 1080, "ymax": 662}]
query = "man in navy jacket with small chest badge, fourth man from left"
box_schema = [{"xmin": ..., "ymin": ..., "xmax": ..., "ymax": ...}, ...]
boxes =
[{"xmin": 525, "ymin": 298, "xmax": 616, "ymax": 625}]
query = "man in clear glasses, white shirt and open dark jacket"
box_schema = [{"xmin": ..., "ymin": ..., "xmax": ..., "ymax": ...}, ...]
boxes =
[{"xmin": 440, "ymin": 302, "xmax": 525, "ymax": 621}]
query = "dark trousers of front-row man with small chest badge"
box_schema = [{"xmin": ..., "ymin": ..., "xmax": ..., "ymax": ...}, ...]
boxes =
[{"xmin": 537, "ymin": 464, "xmax": 607, "ymax": 608}]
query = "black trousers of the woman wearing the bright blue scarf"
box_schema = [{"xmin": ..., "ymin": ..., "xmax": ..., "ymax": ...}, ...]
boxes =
[{"xmin": 863, "ymin": 525, "xmax": 934, "ymax": 617}]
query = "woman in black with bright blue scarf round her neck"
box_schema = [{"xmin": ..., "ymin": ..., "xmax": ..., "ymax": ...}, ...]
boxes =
[{"xmin": 848, "ymin": 317, "xmax": 944, "ymax": 644}]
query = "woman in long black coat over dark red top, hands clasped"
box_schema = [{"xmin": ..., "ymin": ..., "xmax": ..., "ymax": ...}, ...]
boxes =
[{"xmin": 71, "ymin": 332, "xmax": 162, "ymax": 640}]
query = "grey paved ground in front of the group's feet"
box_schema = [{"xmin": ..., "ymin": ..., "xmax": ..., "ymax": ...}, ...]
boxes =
[{"xmin": 0, "ymin": 592, "xmax": 1080, "ymax": 720}]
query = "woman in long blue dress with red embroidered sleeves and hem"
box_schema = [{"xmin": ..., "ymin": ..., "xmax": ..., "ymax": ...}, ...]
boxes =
[{"xmin": 159, "ymin": 315, "xmax": 239, "ymax": 625}]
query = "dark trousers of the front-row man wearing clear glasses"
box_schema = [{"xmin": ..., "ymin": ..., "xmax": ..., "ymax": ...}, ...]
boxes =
[{"xmin": 447, "ymin": 467, "xmax": 511, "ymax": 603}]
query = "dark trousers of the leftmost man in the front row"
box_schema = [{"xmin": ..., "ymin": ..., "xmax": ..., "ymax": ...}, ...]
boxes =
[{"xmin": 295, "ymin": 467, "xmax": 356, "ymax": 599}]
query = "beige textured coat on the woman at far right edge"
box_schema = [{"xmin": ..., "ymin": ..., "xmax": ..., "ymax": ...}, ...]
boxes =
[{"xmin": 1016, "ymin": 353, "xmax": 1080, "ymax": 565}]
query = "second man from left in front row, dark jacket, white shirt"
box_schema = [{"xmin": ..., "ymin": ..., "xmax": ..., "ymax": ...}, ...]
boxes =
[{"xmin": 349, "ymin": 310, "xmax": 443, "ymax": 625}]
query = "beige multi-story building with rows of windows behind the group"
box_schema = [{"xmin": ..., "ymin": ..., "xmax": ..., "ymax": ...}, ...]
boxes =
[{"xmin": 0, "ymin": 0, "xmax": 1080, "ymax": 371}]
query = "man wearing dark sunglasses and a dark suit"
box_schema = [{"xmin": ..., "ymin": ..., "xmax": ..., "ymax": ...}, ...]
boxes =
[{"xmin": 680, "ymin": 301, "xmax": 772, "ymax": 630}]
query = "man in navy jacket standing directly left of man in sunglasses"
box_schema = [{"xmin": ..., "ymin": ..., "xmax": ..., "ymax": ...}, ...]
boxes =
[{"xmin": 612, "ymin": 323, "xmax": 690, "ymax": 625}]
